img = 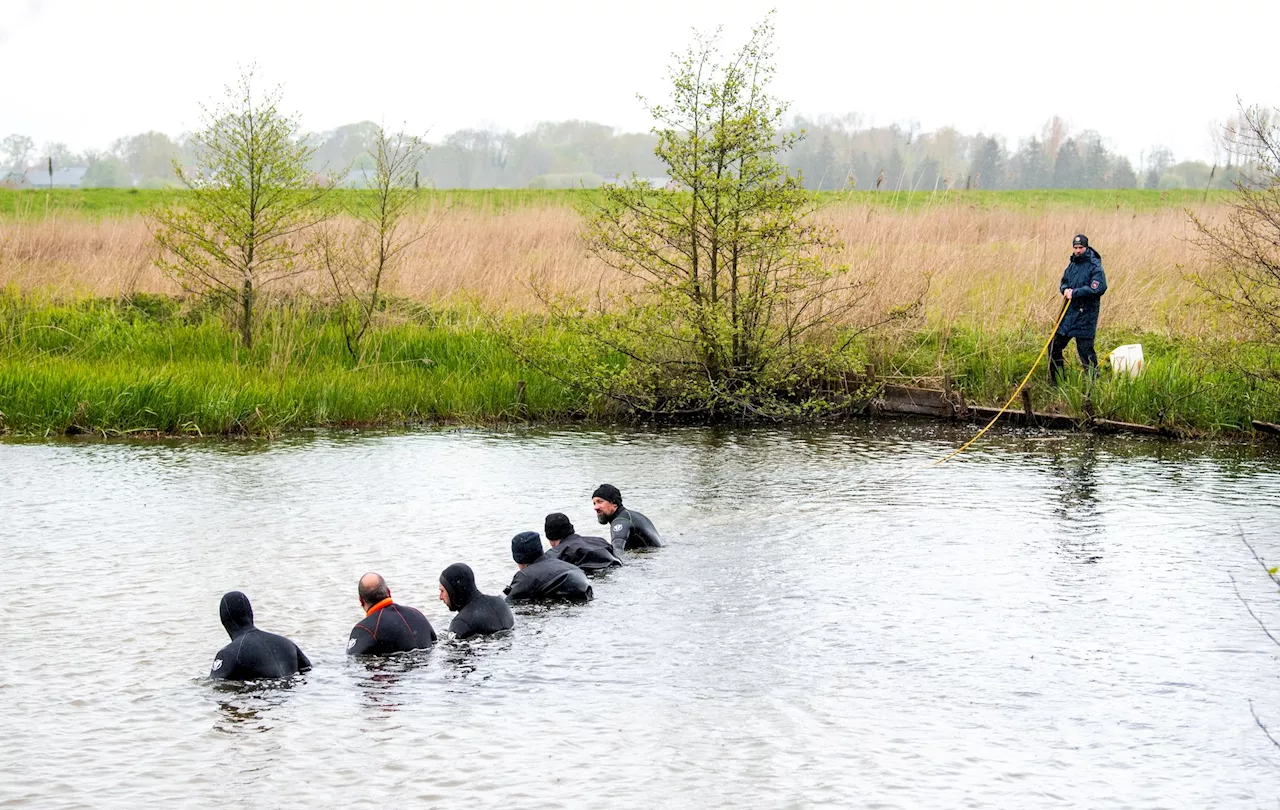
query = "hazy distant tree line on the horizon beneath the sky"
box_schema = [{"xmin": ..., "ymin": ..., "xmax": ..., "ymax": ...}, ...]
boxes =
[{"xmin": 0, "ymin": 115, "xmax": 1239, "ymax": 192}]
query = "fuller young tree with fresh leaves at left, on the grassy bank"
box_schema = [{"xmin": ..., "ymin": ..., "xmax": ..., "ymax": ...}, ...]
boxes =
[{"xmin": 151, "ymin": 70, "xmax": 328, "ymax": 348}]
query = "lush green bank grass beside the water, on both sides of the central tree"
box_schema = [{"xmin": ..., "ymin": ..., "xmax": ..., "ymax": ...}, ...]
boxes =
[{"xmin": 0, "ymin": 292, "xmax": 1280, "ymax": 435}]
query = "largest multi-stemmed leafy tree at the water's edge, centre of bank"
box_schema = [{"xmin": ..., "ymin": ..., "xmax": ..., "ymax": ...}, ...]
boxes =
[{"xmin": 527, "ymin": 17, "xmax": 890, "ymax": 416}]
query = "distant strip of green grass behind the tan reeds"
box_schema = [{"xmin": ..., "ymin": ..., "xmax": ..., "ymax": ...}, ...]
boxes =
[{"xmin": 0, "ymin": 188, "xmax": 1228, "ymax": 220}]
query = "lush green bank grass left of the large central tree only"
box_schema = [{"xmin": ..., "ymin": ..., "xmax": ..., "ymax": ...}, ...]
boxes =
[{"xmin": 0, "ymin": 294, "xmax": 581, "ymax": 435}]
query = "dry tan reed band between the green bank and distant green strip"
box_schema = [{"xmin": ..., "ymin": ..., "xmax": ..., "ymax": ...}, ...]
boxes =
[{"xmin": 0, "ymin": 205, "xmax": 1221, "ymax": 337}]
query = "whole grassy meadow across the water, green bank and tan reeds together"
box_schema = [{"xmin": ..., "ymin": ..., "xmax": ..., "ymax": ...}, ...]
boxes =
[{"xmin": 0, "ymin": 189, "xmax": 1280, "ymax": 434}]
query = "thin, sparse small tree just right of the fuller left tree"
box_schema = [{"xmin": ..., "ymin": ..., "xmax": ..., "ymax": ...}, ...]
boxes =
[{"xmin": 320, "ymin": 127, "xmax": 430, "ymax": 365}]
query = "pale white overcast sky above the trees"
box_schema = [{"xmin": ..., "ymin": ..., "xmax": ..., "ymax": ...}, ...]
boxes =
[{"xmin": 0, "ymin": 0, "xmax": 1280, "ymax": 163}]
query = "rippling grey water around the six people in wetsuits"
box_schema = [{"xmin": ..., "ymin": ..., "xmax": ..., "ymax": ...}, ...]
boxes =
[{"xmin": 0, "ymin": 422, "xmax": 1280, "ymax": 807}]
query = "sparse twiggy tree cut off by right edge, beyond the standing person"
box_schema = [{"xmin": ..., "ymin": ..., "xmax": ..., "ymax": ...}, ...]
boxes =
[{"xmin": 1190, "ymin": 106, "xmax": 1280, "ymax": 394}]
